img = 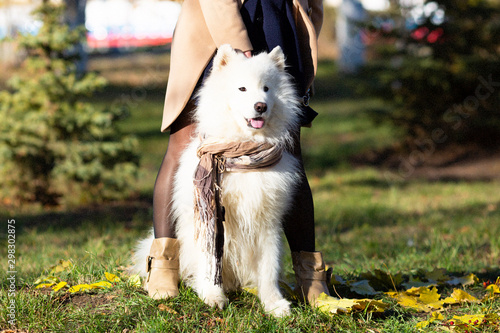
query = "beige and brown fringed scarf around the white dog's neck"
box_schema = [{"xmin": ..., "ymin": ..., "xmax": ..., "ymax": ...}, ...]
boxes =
[{"xmin": 194, "ymin": 139, "xmax": 283, "ymax": 285}]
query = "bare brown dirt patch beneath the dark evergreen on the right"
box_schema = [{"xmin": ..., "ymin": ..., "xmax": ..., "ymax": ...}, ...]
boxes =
[{"xmin": 351, "ymin": 145, "xmax": 500, "ymax": 181}]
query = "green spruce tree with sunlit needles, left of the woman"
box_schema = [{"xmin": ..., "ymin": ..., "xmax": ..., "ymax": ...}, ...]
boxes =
[{"xmin": 0, "ymin": 3, "xmax": 138, "ymax": 205}]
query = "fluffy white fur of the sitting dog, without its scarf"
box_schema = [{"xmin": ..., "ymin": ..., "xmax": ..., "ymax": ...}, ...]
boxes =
[{"xmin": 136, "ymin": 45, "xmax": 299, "ymax": 316}]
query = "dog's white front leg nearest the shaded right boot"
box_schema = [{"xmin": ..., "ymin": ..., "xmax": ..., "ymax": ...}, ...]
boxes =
[{"xmin": 258, "ymin": 228, "xmax": 290, "ymax": 317}]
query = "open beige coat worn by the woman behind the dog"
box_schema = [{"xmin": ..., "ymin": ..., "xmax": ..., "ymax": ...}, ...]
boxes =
[{"xmin": 161, "ymin": 0, "xmax": 323, "ymax": 131}]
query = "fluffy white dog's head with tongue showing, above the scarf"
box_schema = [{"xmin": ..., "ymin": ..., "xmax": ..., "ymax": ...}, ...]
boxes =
[{"xmin": 196, "ymin": 45, "xmax": 298, "ymax": 140}]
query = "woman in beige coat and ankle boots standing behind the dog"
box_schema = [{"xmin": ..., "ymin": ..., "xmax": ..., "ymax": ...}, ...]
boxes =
[{"xmin": 146, "ymin": 0, "xmax": 328, "ymax": 304}]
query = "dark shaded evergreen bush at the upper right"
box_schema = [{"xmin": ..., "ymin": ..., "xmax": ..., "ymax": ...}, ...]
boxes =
[{"xmin": 367, "ymin": 0, "xmax": 500, "ymax": 149}]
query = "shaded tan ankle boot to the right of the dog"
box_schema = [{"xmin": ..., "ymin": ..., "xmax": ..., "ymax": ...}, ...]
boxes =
[{"xmin": 292, "ymin": 251, "xmax": 330, "ymax": 306}]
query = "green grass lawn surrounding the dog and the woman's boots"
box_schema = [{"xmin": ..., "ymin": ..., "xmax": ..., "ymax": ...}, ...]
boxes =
[{"xmin": 0, "ymin": 55, "xmax": 500, "ymax": 332}]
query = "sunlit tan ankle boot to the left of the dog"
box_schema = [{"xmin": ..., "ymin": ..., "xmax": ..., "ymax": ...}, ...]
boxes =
[{"xmin": 146, "ymin": 237, "xmax": 179, "ymax": 299}]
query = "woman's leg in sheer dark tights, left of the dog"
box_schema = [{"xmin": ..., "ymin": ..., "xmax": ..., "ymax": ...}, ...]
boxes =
[{"xmin": 153, "ymin": 102, "xmax": 195, "ymax": 238}]
